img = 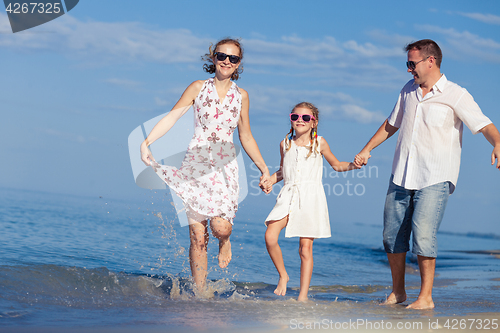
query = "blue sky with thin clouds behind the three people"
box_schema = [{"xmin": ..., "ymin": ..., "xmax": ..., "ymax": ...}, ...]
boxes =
[{"xmin": 0, "ymin": 0, "xmax": 500, "ymax": 234}]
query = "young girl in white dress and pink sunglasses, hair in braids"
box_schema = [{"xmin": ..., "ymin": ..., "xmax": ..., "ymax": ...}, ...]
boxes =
[{"xmin": 263, "ymin": 102, "xmax": 358, "ymax": 301}]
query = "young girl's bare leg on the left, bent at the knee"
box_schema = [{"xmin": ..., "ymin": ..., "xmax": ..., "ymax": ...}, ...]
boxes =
[{"xmin": 265, "ymin": 215, "xmax": 289, "ymax": 296}]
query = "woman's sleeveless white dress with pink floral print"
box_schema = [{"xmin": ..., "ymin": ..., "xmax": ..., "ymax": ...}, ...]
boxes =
[{"xmin": 153, "ymin": 78, "xmax": 241, "ymax": 223}]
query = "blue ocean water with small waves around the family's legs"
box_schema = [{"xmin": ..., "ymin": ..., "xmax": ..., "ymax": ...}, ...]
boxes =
[{"xmin": 0, "ymin": 189, "xmax": 500, "ymax": 331}]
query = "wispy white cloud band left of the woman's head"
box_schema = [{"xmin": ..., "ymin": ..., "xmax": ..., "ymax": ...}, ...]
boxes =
[{"xmin": 0, "ymin": 13, "xmax": 210, "ymax": 63}]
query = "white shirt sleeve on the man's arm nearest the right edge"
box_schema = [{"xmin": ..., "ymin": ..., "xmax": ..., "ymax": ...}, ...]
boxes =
[{"xmin": 453, "ymin": 88, "xmax": 491, "ymax": 134}]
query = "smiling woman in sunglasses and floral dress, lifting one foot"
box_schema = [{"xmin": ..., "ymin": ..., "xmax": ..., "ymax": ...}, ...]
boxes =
[{"xmin": 141, "ymin": 39, "xmax": 270, "ymax": 293}]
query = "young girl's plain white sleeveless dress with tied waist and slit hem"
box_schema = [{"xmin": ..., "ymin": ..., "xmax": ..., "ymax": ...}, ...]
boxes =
[{"xmin": 266, "ymin": 136, "xmax": 331, "ymax": 238}]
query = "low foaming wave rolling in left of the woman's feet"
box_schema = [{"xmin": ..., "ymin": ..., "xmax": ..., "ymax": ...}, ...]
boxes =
[{"xmin": 0, "ymin": 265, "xmax": 168, "ymax": 307}]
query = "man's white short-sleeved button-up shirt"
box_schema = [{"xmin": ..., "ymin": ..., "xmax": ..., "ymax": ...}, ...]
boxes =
[{"xmin": 387, "ymin": 74, "xmax": 491, "ymax": 194}]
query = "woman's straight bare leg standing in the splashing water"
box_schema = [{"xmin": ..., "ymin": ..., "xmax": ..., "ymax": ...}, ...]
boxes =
[{"xmin": 188, "ymin": 215, "xmax": 208, "ymax": 295}]
